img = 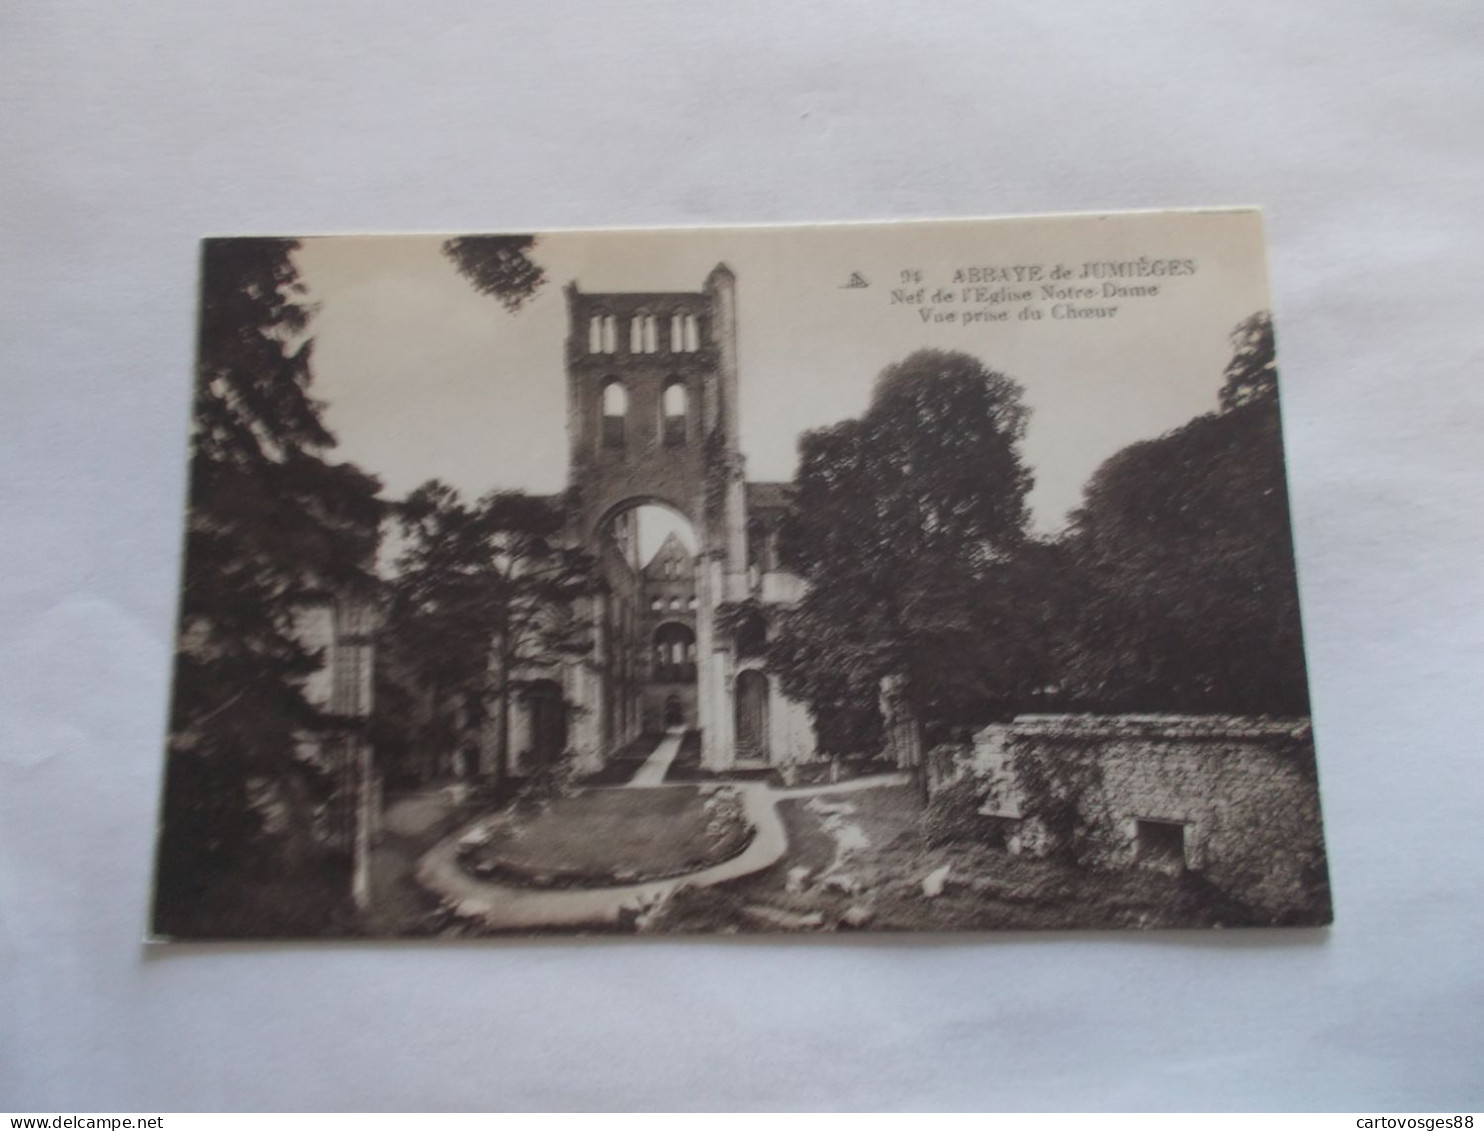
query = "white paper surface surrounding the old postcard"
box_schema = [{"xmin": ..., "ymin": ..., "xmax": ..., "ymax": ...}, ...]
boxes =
[{"xmin": 0, "ymin": 0, "xmax": 1484, "ymax": 1112}]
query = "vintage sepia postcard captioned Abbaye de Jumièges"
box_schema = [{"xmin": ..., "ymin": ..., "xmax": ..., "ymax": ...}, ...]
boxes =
[{"xmin": 151, "ymin": 209, "xmax": 1331, "ymax": 940}]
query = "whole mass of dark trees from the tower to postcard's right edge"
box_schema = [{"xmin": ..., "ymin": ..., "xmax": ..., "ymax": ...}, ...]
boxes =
[{"xmin": 770, "ymin": 312, "xmax": 1309, "ymax": 745}]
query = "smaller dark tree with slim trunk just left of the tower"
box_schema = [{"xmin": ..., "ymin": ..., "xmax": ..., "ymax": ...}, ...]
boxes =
[{"xmin": 392, "ymin": 479, "xmax": 592, "ymax": 790}]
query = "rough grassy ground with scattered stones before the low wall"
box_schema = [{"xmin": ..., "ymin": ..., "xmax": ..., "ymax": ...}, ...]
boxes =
[{"xmin": 654, "ymin": 787, "xmax": 1250, "ymax": 932}]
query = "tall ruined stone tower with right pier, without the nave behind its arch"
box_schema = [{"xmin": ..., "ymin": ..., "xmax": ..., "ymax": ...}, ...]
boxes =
[{"xmin": 567, "ymin": 264, "xmax": 748, "ymax": 769}]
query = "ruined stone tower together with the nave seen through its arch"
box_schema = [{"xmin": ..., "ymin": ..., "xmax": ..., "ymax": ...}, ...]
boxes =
[{"xmin": 567, "ymin": 264, "xmax": 748, "ymax": 770}]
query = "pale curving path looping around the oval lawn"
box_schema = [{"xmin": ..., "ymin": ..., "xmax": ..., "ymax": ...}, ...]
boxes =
[{"xmin": 417, "ymin": 773, "xmax": 910, "ymax": 931}]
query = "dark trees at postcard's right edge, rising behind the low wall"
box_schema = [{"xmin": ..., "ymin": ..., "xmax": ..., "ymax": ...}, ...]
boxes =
[{"xmin": 1066, "ymin": 313, "xmax": 1309, "ymax": 714}]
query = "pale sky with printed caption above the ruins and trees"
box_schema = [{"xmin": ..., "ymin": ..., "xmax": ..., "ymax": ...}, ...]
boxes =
[{"xmin": 297, "ymin": 212, "xmax": 1267, "ymax": 540}]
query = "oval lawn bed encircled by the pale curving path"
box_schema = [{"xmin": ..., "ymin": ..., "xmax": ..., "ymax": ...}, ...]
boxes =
[{"xmin": 459, "ymin": 787, "xmax": 754, "ymax": 889}]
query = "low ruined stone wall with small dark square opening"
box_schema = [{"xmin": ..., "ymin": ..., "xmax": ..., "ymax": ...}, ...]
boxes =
[{"xmin": 930, "ymin": 715, "xmax": 1324, "ymax": 919}]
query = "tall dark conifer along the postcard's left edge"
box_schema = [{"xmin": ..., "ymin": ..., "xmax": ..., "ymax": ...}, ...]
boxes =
[{"xmin": 159, "ymin": 239, "xmax": 380, "ymax": 929}]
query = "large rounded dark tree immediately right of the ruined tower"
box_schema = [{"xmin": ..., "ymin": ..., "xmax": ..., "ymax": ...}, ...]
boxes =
[{"xmin": 772, "ymin": 350, "xmax": 1031, "ymax": 745}]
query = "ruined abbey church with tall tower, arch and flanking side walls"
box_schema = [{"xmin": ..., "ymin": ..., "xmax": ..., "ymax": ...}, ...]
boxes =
[{"xmin": 561, "ymin": 264, "xmax": 815, "ymax": 772}]
